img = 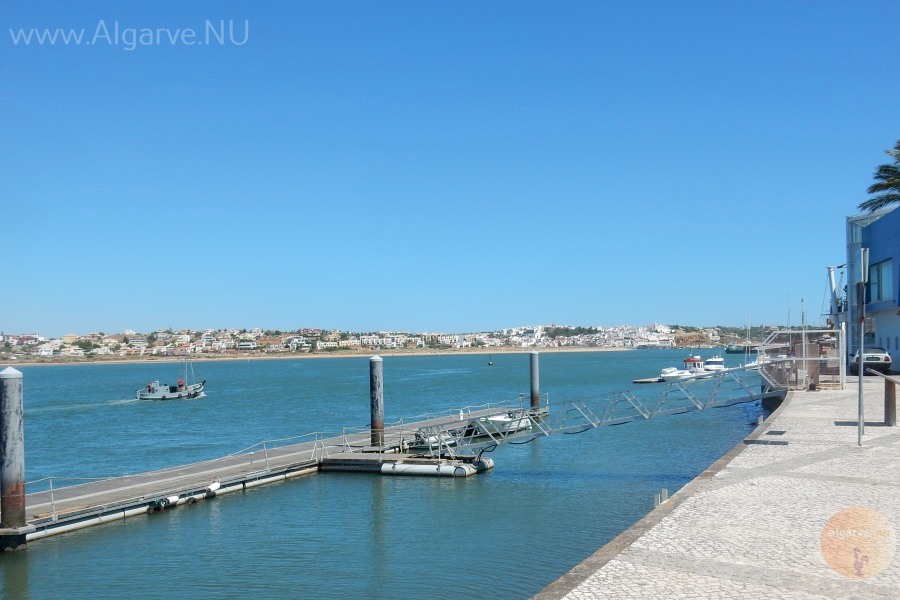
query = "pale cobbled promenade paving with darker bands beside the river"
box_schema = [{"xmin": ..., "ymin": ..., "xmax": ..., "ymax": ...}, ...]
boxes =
[{"xmin": 536, "ymin": 377, "xmax": 900, "ymax": 600}]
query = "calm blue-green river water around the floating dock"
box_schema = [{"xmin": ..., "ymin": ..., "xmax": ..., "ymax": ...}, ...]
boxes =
[{"xmin": 0, "ymin": 350, "xmax": 761, "ymax": 599}]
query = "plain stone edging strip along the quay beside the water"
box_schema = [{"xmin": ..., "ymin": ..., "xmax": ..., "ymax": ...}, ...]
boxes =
[{"xmin": 532, "ymin": 391, "xmax": 793, "ymax": 600}]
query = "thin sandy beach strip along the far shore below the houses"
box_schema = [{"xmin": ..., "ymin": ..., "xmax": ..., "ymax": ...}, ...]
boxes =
[{"xmin": 0, "ymin": 346, "xmax": 633, "ymax": 368}]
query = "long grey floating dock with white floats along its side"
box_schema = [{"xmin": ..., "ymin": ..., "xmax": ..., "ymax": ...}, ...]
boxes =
[{"xmin": 17, "ymin": 408, "xmax": 506, "ymax": 541}]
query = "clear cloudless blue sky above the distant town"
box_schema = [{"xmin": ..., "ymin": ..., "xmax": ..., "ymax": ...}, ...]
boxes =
[{"xmin": 0, "ymin": 0, "xmax": 900, "ymax": 336}]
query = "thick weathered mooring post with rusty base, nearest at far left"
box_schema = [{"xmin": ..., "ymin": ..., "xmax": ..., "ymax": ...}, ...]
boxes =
[{"xmin": 0, "ymin": 367, "xmax": 33, "ymax": 550}]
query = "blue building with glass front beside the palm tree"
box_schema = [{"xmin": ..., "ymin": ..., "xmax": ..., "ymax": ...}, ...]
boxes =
[{"xmin": 844, "ymin": 206, "xmax": 900, "ymax": 371}]
